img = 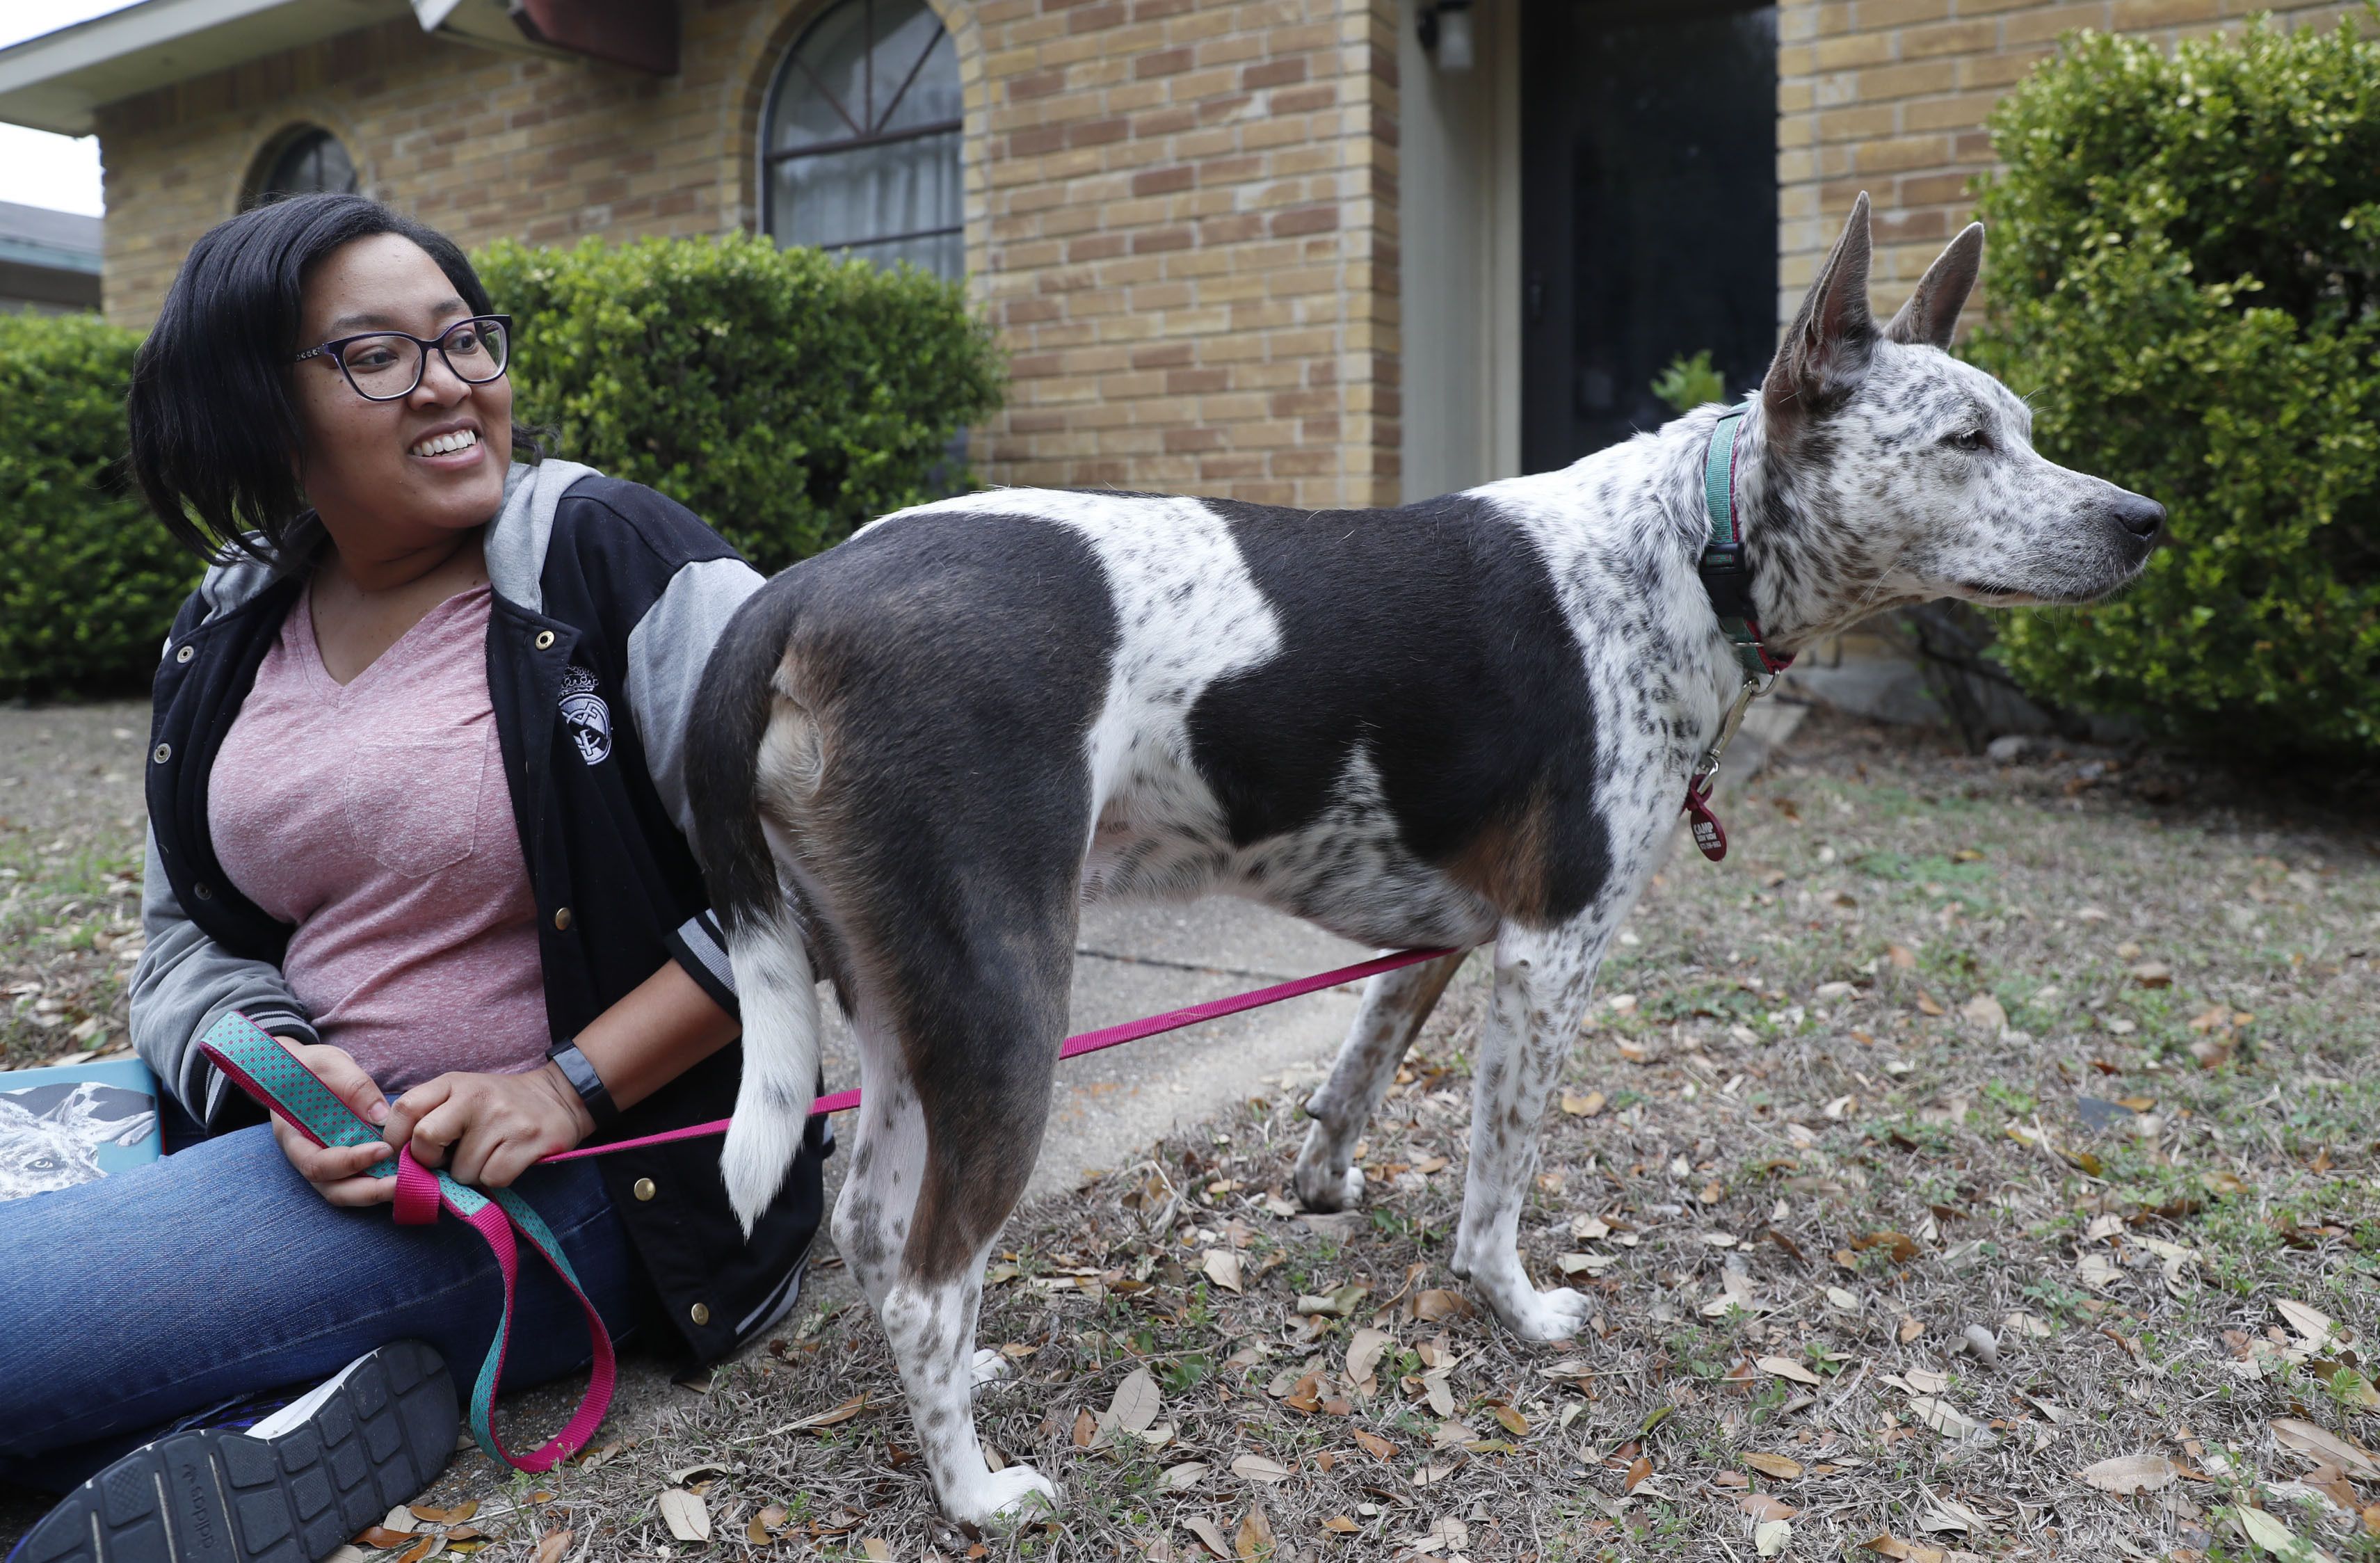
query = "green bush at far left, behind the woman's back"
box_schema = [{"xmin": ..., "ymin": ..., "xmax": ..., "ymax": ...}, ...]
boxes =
[{"xmin": 0, "ymin": 314, "xmax": 200, "ymax": 697}]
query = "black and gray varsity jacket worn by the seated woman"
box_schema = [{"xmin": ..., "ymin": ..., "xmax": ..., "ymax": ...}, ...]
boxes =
[{"xmin": 131, "ymin": 461, "xmax": 833, "ymax": 1363}]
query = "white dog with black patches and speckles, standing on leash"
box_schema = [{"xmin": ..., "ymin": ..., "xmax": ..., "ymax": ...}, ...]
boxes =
[{"xmin": 688, "ymin": 198, "xmax": 2164, "ymax": 1520}]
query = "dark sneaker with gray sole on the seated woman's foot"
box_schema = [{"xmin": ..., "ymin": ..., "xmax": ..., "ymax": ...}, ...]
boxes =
[{"xmin": 10, "ymin": 1340, "xmax": 457, "ymax": 1563}]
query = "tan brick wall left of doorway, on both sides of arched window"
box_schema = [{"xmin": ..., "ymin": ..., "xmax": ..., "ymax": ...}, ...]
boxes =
[{"xmin": 100, "ymin": 0, "xmax": 1397, "ymax": 504}]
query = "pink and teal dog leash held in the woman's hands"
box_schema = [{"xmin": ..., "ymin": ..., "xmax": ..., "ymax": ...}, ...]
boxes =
[{"xmin": 200, "ymin": 949, "xmax": 1456, "ymax": 1470}]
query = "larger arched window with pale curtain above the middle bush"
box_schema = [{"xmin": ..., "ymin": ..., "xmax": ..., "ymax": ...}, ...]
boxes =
[{"xmin": 762, "ymin": 0, "xmax": 966, "ymax": 278}]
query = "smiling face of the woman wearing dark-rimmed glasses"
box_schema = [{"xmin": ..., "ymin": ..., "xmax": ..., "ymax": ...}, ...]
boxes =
[{"xmin": 290, "ymin": 233, "xmax": 512, "ymax": 552}]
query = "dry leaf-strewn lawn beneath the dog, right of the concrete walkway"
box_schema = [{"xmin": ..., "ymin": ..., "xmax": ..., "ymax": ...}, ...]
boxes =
[{"xmin": 14, "ymin": 716, "xmax": 2380, "ymax": 1563}]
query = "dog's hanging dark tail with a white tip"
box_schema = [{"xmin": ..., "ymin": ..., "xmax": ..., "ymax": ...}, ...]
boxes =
[{"xmin": 686, "ymin": 576, "xmax": 819, "ymax": 1237}]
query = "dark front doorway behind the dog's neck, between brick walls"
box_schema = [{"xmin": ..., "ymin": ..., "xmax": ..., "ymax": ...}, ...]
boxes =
[{"xmin": 1521, "ymin": 0, "xmax": 1778, "ymax": 471}]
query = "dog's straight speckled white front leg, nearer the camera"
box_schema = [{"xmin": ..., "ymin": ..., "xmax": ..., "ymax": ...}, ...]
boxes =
[{"xmin": 1454, "ymin": 913, "xmax": 1611, "ymax": 1340}]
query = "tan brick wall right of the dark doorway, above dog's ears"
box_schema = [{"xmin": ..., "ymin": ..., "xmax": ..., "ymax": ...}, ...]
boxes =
[{"xmin": 1778, "ymin": 0, "xmax": 2345, "ymax": 321}]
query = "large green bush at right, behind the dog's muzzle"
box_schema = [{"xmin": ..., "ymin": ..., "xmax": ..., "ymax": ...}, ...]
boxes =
[{"xmin": 1968, "ymin": 24, "xmax": 2380, "ymax": 752}]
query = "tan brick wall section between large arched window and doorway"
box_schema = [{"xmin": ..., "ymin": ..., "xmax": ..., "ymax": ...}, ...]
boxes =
[{"xmin": 981, "ymin": 0, "xmax": 1397, "ymax": 504}]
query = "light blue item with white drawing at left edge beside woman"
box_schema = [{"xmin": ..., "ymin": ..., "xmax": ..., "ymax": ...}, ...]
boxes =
[{"xmin": 0, "ymin": 1059, "xmax": 164, "ymax": 1199}]
